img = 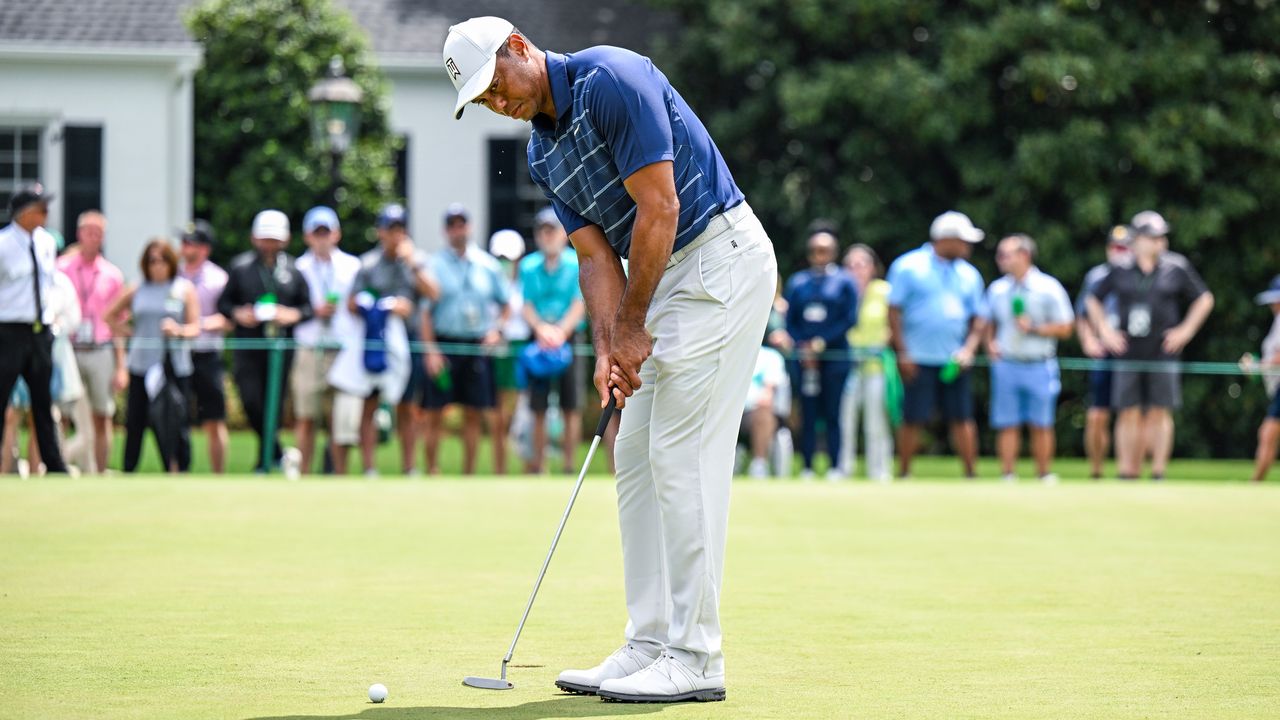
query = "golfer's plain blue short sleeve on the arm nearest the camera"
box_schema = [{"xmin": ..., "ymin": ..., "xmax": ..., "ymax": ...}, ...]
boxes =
[{"xmin": 588, "ymin": 65, "xmax": 676, "ymax": 179}]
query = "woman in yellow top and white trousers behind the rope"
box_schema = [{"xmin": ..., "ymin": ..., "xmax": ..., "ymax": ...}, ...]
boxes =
[{"xmin": 840, "ymin": 245, "xmax": 893, "ymax": 483}]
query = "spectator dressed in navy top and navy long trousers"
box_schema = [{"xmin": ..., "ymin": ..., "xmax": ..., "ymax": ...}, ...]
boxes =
[{"xmin": 786, "ymin": 232, "xmax": 858, "ymax": 480}]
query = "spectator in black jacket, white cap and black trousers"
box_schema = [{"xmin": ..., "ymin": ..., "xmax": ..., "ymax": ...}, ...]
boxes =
[{"xmin": 218, "ymin": 210, "xmax": 312, "ymax": 477}]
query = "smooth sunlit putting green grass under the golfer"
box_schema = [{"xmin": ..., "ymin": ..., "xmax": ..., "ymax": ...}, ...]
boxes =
[{"xmin": 0, "ymin": 468, "xmax": 1280, "ymax": 720}]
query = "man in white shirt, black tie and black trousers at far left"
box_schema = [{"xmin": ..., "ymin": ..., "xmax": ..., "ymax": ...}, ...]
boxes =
[{"xmin": 0, "ymin": 183, "xmax": 67, "ymax": 473}]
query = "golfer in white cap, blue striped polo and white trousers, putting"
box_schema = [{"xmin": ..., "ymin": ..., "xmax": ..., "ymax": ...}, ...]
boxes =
[{"xmin": 444, "ymin": 17, "xmax": 777, "ymax": 702}]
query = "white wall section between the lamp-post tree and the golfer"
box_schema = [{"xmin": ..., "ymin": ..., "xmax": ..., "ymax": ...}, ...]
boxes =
[{"xmin": 385, "ymin": 64, "xmax": 529, "ymax": 249}]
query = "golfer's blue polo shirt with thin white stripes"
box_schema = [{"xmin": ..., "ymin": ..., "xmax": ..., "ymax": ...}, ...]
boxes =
[{"xmin": 529, "ymin": 45, "xmax": 742, "ymax": 258}]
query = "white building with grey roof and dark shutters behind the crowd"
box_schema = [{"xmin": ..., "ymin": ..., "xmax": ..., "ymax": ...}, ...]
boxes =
[{"xmin": 0, "ymin": 0, "xmax": 658, "ymax": 278}]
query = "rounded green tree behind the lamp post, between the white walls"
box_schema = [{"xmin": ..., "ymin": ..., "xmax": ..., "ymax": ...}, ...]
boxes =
[{"xmin": 187, "ymin": 0, "xmax": 397, "ymax": 260}]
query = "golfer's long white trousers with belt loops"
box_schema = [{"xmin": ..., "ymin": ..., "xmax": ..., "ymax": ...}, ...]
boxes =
[{"xmin": 614, "ymin": 204, "xmax": 777, "ymax": 675}]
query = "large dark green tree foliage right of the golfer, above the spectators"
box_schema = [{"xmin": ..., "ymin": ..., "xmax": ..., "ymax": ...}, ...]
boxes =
[{"xmin": 654, "ymin": 0, "xmax": 1280, "ymax": 456}]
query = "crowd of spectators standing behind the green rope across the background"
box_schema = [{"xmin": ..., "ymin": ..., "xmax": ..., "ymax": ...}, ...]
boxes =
[{"xmin": 0, "ymin": 190, "xmax": 1280, "ymax": 483}]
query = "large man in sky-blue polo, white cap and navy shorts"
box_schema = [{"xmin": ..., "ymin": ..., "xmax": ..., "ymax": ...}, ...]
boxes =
[{"xmin": 888, "ymin": 210, "xmax": 986, "ymax": 478}]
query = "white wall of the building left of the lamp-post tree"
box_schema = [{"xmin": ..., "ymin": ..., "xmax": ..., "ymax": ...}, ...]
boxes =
[{"xmin": 0, "ymin": 49, "xmax": 196, "ymax": 279}]
